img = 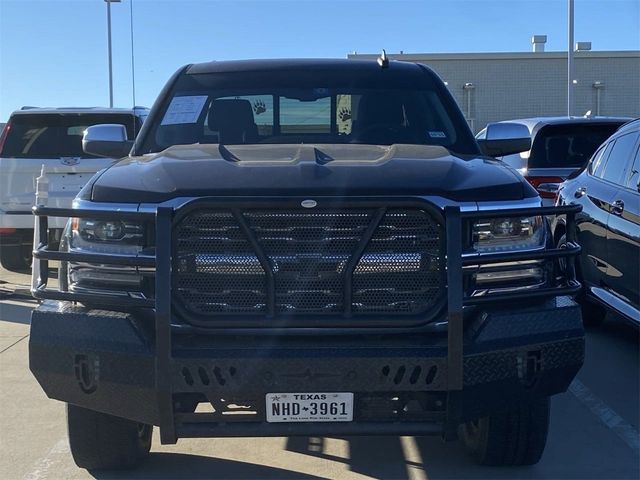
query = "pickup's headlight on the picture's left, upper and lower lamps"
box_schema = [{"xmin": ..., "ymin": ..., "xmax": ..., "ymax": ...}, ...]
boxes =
[{"xmin": 66, "ymin": 218, "xmax": 147, "ymax": 294}]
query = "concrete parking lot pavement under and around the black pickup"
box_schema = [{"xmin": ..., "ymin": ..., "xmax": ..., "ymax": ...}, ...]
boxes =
[{"xmin": 0, "ymin": 270, "xmax": 640, "ymax": 480}]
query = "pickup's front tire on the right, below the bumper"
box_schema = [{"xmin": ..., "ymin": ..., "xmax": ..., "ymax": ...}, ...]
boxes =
[{"xmin": 460, "ymin": 397, "xmax": 549, "ymax": 466}]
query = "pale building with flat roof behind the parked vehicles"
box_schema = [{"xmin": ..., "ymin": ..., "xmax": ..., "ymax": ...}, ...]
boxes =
[{"xmin": 348, "ymin": 48, "xmax": 640, "ymax": 133}]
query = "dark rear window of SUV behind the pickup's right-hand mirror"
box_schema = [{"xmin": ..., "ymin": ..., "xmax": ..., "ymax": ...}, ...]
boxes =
[{"xmin": 529, "ymin": 122, "xmax": 622, "ymax": 168}]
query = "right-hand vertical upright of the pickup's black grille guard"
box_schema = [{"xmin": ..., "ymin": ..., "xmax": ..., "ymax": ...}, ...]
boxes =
[{"xmin": 445, "ymin": 207, "xmax": 464, "ymax": 390}]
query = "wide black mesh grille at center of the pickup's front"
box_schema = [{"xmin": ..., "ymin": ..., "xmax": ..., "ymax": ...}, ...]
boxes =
[{"xmin": 174, "ymin": 209, "xmax": 444, "ymax": 320}]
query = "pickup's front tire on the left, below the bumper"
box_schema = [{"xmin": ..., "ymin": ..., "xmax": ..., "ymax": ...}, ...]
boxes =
[{"xmin": 67, "ymin": 404, "xmax": 153, "ymax": 470}]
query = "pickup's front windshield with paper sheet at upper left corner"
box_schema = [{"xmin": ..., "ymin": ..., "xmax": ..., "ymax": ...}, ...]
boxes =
[{"xmin": 141, "ymin": 70, "xmax": 477, "ymax": 153}]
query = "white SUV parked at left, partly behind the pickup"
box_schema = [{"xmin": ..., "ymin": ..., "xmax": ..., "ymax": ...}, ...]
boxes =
[{"xmin": 0, "ymin": 107, "xmax": 149, "ymax": 270}]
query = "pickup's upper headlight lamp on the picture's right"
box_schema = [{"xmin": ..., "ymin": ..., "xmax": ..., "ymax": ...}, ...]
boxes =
[{"xmin": 473, "ymin": 216, "xmax": 546, "ymax": 253}]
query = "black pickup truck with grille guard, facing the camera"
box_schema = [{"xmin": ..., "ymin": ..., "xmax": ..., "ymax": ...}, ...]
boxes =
[{"xmin": 29, "ymin": 56, "xmax": 584, "ymax": 469}]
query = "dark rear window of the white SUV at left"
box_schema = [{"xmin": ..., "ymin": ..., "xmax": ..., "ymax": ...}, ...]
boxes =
[{"xmin": 0, "ymin": 113, "xmax": 139, "ymax": 158}]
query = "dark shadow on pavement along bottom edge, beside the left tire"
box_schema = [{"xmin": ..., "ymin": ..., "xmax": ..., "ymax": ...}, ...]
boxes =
[{"xmin": 89, "ymin": 453, "xmax": 324, "ymax": 480}]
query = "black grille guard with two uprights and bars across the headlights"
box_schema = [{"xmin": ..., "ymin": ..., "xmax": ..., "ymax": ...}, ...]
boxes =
[{"xmin": 31, "ymin": 198, "xmax": 582, "ymax": 443}]
